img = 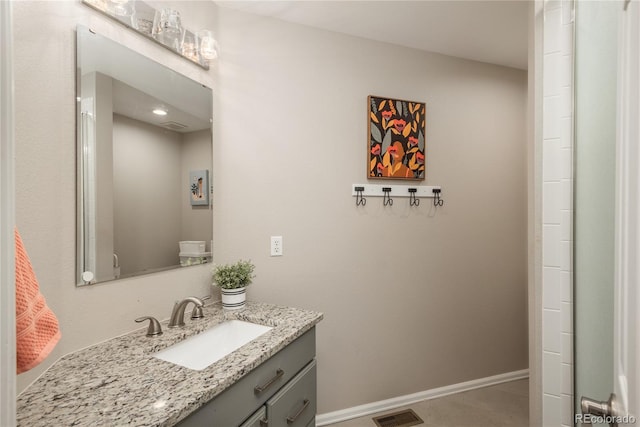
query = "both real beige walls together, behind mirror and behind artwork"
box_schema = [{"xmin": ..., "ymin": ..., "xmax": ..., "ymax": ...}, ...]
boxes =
[{"xmin": 15, "ymin": 2, "xmax": 527, "ymax": 413}]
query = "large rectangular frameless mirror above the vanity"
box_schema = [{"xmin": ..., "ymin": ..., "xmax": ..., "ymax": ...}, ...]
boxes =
[{"xmin": 76, "ymin": 26, "xmax": 213, "ymax": 285}]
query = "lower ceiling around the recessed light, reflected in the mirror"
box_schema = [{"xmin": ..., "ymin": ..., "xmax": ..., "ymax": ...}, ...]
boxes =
[{"xmin": 113, "ymin": 80, "xmax": 211, "ymax": 133}]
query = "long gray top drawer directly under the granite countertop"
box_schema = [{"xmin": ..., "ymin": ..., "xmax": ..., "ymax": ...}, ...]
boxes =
[{"xmin": 179, "ymin": 328, "xmax": 316, "ymax": 427}]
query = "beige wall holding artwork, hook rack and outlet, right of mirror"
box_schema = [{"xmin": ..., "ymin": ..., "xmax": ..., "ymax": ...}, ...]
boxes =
[{"xmin": 214, "ymin": 9, "xmax": 527, "ymax": 413}]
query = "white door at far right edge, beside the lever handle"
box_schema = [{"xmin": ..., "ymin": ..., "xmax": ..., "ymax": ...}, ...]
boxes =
[{"xmin": 613, "ymin": 1, "xmax": 640, "ymax": 425}]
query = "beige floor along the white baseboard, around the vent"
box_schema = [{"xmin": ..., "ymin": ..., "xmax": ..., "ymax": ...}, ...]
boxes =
[{"xmin": 331, "ymin": 379, "xmax": 529, "ymax": 427}]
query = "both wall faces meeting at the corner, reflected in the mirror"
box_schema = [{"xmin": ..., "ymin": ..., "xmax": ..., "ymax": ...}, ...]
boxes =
[{"xmin": 109, "ymin": 114, "xmax": 213, "ymax": 275}]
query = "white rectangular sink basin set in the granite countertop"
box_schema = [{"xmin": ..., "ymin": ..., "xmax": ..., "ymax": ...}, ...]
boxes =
[{"xmin": 158, "ymin": 320, "xmax": 272, "ymax": 371}]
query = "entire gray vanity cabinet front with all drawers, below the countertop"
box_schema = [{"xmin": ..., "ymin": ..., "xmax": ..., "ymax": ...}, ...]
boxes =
[{"xmin": 179, "ymin": 328, "xmax": 316, "ymax": 427}]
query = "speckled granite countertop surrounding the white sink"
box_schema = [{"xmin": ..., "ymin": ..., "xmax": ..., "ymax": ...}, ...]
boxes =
[{"xmin": 17, "ymin": 302, "xmax": 322, "ymax": 427}]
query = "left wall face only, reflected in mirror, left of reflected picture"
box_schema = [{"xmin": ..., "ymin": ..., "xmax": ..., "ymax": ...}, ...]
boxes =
[{"xmin": 113, "ymin": 114, "xmax": 181, "ymax": 275}]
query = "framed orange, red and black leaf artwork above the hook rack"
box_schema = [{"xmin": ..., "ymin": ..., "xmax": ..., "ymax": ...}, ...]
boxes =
[{"xmin": 367, "ymin": 95, "xmax": 426, "ymax": 180}]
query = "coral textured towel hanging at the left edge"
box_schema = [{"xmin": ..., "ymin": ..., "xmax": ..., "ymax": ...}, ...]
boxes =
[{"xmin": 15, "ymin": 229, "xmax": 60, "ymax": 374}]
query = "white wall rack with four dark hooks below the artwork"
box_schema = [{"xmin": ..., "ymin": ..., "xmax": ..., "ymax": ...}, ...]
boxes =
[{"xmin": 351, "ymin": 184, "xmax": 444, "ymax": 207}]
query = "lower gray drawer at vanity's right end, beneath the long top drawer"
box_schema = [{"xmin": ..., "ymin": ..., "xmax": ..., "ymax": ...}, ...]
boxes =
[{"xmin": 267, "ymin": 360, "xmax": 316, "ymax": 427}]
